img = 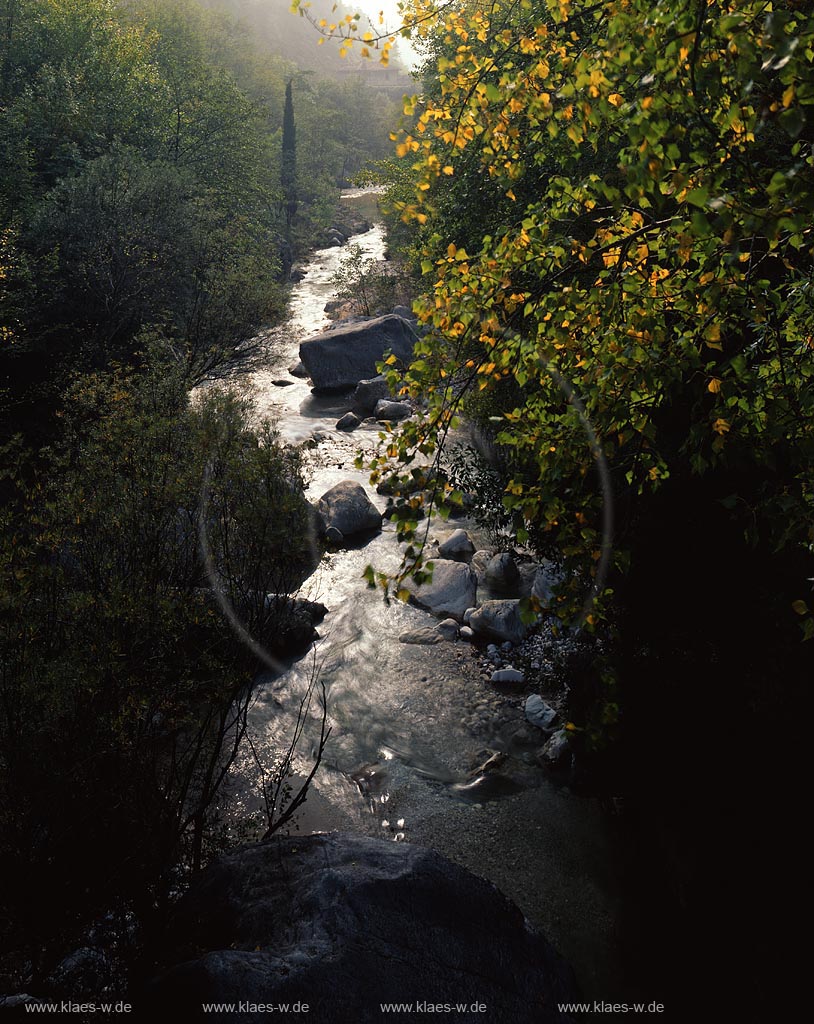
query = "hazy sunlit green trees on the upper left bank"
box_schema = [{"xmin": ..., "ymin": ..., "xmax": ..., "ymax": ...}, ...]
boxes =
[{"xmin": 0, "ymin": 0, "xmax": 401, "ymax": 436}]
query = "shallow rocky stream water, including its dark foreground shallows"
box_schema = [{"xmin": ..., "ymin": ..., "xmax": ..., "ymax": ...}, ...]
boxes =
[{"xmin": 206, "ymin": 192, "xmax": 618, "ymax": 997}]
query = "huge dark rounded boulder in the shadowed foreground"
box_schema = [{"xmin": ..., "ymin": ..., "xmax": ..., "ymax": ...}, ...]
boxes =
[{"xmin": 145, "ymin": 833, "xmax": 575, "ymax": 1024}]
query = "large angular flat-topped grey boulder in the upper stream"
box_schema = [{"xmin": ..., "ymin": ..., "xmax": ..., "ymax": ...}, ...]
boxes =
[{"xmin": 300, "ymin": 313, "xmax": 417, "ymax": 392}]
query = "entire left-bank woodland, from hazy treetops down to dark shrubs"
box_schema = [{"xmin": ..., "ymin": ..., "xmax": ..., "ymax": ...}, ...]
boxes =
[{"xmin": 0, "ymin": 0, "xmax": 401, "ymax": 986}]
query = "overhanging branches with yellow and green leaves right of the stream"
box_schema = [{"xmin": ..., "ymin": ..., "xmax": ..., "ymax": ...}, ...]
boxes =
[{"xmin": 348, "ymin": 0, "xmax": 814, "ymax": 632}]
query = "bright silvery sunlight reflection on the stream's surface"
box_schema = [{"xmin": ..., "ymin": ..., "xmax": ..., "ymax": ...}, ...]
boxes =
[{"xmin": 209, "ymin": 207, "xmax": 544, "ymax": 840}]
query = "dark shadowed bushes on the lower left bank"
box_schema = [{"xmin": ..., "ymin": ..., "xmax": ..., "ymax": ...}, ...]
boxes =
[{"xmin": 0, "ymin": 365, "xmax": 317, "ymax": 974}]
